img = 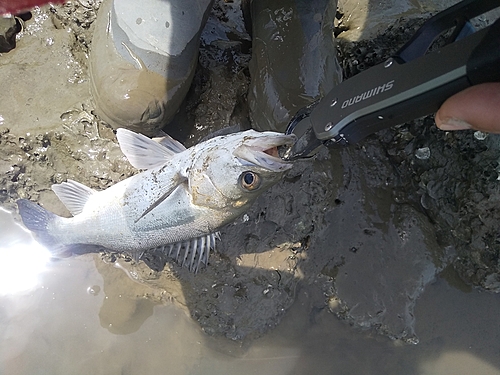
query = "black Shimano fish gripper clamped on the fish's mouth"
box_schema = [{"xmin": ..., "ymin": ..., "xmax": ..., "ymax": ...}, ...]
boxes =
[{"xmin": 284, "ymin": 0, "xmax": 500, "ymax": 160}]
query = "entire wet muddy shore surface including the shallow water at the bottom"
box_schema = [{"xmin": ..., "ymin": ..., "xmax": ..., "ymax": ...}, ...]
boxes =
[{"xmin": 0, "ymin": 1, "xmax": 500, "ymax": 375}]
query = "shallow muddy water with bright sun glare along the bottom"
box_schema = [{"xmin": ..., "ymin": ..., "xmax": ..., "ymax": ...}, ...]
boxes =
[{"xmin": 0, "ymin": 211, "xmax": 500, "ymax": 375}]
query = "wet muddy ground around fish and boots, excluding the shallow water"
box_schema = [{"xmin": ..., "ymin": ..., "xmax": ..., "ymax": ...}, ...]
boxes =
[{"xmin": 0, "ymin": 1, "xmax": 500, "ymax": 343}]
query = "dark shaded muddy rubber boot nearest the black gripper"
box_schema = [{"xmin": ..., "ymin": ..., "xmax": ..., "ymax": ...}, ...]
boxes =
[{"xmin": 244, "ymin": 0, "xmax": 342, "ymax": 132}]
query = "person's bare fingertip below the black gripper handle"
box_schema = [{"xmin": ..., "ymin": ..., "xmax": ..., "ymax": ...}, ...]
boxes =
[{"xmin": 435, "ymin": 82, "xmax": 500, "ymax": 133}]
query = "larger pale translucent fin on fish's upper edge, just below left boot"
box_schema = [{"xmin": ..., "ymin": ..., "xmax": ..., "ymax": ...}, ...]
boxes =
[{"xmin": 116, "ymin": 128, "xmax": 185, "ymax": 169}]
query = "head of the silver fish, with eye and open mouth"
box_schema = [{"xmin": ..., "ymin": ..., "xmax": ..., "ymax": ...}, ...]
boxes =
[{"xmin": 189, "ymin": 130, "xmax": 296, "ymax": 220}]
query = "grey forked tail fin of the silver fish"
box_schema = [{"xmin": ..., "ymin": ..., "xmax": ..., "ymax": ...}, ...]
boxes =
[{"xmin": 17, "ymin": 199, "xmax": 58, "ymax": 249}]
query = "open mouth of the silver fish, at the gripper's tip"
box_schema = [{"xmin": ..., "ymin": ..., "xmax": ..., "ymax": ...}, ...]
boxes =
[{"xmin": 234, "ymin": 132, "xmax": 297, "ymax": 172}]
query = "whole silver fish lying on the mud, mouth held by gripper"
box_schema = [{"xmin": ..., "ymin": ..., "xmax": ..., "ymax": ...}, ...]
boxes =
[{"xmin": 17, "ymin": 129, "xmax": 295, "ymax": 272}]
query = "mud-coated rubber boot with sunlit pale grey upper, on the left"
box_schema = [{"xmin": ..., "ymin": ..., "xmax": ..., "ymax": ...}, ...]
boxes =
[{"xmin": 89, "ymin": 0, "xmax": 213, "ymax": 136}]
